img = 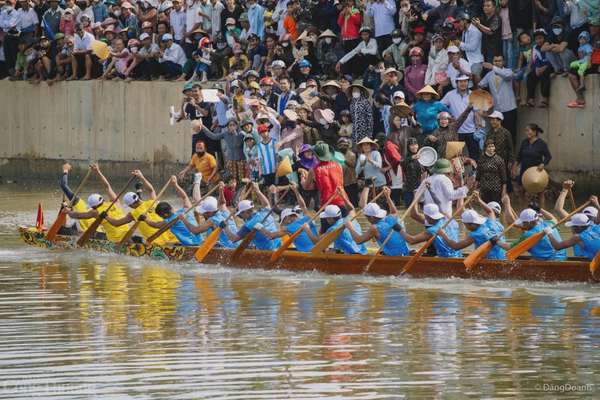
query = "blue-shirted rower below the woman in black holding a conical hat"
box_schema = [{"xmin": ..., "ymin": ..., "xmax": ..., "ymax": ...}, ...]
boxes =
[{"xmin": 515, "ymin": 208, "xmax": 567, "ymax": 261}]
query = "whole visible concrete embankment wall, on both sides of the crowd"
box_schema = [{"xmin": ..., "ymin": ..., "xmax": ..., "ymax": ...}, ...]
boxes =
[{"xmin": 0, "ymin": 75, "xmax": 600, "ymax": 186}]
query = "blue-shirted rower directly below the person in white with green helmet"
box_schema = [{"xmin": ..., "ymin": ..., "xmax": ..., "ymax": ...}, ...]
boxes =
[{"xmin": 401, "ymin": 203, "xmax": 462, "ymax": 258}]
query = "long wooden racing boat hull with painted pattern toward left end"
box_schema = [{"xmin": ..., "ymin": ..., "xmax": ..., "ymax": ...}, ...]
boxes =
[{"xmin": 19, "ymin": 227, "xmax": 600, "ymax": 283}]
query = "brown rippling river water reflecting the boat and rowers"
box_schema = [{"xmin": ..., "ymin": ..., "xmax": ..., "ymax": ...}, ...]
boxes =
[{"xmin": 0, "ymin": 185, "xmax": 600, "ymax": 399}]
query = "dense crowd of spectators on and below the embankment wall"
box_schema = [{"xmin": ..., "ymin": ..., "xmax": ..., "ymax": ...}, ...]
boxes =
[{"xmin": 0, "ymin": 0, "xmax": 600, "ymax": 209}]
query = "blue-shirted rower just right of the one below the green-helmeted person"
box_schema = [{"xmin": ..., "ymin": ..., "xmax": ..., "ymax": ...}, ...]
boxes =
[{"xmin": 439, "ymin": 210, "xmax": 510, "ymax": 260}]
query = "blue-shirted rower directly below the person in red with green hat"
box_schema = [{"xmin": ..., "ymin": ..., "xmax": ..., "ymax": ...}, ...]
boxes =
[{"xmin": 304, "ymin": 187, "xmax": 367, "ymax": 254}]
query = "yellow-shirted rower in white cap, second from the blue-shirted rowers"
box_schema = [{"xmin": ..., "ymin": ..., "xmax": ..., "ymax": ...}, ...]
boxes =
[{"xmin": 68, "ymin": 164, "xmax": 129, "ymax": 243}]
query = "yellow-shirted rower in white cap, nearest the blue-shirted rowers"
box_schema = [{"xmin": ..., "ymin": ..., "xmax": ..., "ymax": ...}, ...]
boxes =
[{"xmin": 106, "ymin": 169, "xmax": 178, "ymax": 246}]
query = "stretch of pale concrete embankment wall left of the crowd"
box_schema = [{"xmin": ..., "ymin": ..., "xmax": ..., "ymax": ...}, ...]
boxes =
[{"xmin": 0, "ymin": 81, "xmax": 191, "ymax": 180}]
